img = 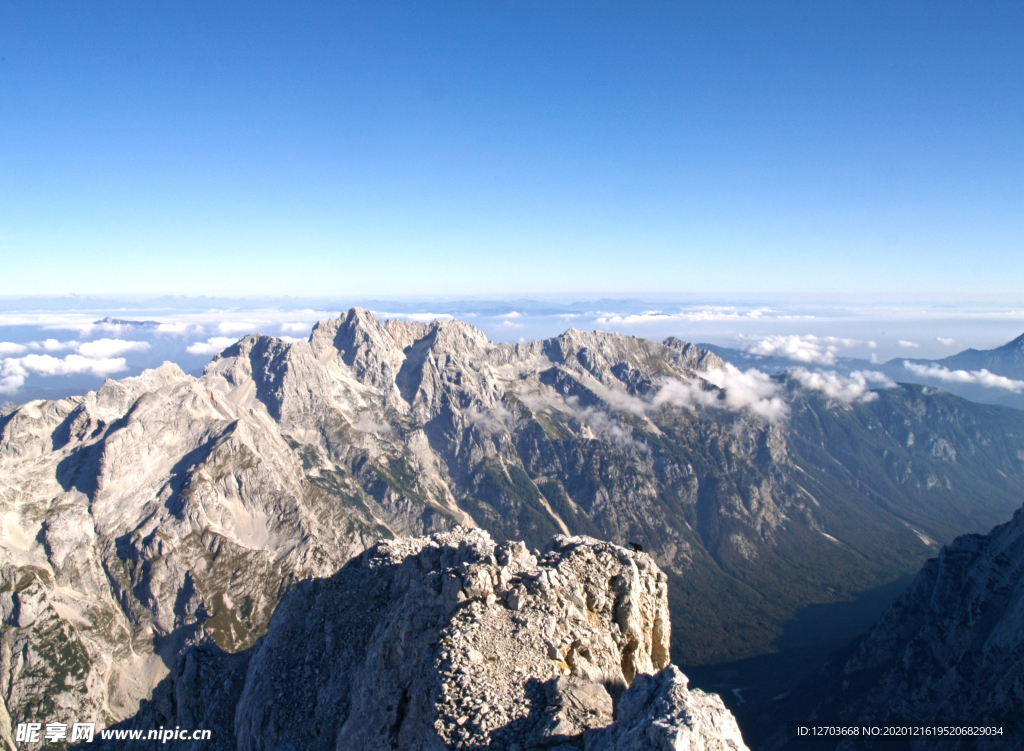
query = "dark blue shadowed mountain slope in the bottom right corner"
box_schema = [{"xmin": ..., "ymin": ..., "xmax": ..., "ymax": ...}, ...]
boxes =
[{"xmin": 774, "ymin": 499, "xmax": 1024, "ymax": 749}]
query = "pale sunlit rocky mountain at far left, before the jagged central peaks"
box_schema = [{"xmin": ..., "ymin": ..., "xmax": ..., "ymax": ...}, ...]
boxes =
[{"xmin": 0, "ymin": 365, "xmax": 378, "ymax": 738}]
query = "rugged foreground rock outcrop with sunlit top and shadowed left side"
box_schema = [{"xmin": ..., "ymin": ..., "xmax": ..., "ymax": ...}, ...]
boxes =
[{"xmin": 112, "ymin": 529, "xmax": 745, "ymax": 751}]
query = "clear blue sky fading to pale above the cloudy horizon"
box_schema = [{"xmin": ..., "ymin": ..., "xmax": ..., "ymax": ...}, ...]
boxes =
[{"xmin": 0, "ymin": 0, "xmax": 1024, "ymax": 301}]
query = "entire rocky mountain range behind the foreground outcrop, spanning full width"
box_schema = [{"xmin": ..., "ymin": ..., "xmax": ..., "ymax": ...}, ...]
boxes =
[{"xmin": 0, "ymin": 309, "xmax": 1024, "ymax": 736}]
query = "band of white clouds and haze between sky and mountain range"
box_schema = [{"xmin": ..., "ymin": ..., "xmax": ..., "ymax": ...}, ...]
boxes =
[{"xmin": 0, "ymin": 298, "xmax": 1024, "ymax": 409}]
